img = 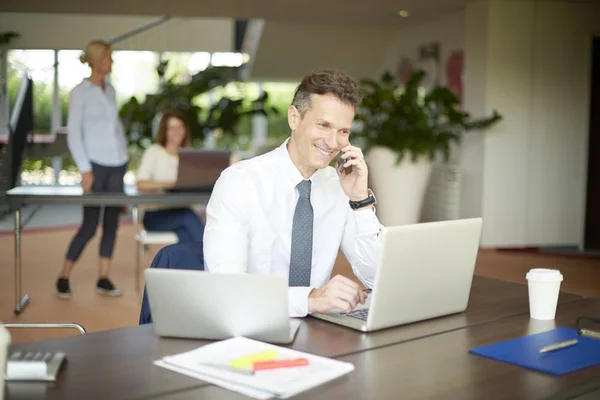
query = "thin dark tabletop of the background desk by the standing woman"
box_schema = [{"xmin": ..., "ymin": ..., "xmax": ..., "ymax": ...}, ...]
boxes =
[{"xmin": 6, "ymin": 185, "xmax": 211, "ymax": 205}]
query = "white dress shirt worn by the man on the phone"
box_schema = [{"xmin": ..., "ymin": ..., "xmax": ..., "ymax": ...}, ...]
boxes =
[{"xmin": 204, "ymin": 139, "xmax": 382, "ymax": 317}]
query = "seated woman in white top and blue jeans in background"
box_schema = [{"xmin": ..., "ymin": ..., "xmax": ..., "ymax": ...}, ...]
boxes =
[{"xmin": 137, "ymin": 110, "xmax": 204, "ymax": 243}]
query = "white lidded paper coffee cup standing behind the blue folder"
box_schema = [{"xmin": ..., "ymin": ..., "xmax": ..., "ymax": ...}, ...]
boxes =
[{"xmin": 527, "ymin": 268, "xmax": 563, "ymax": 320}]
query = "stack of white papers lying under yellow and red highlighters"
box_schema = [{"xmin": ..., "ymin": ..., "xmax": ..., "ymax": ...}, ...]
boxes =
[{"xmin": 154, "ymin": 337, "xmax": 354, "ymax": 399}]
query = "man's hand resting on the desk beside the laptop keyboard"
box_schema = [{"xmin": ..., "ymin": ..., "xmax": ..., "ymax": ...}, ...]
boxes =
[{"xmin": 308, "ymin": 275, "xmax": 367, "ymax": 313}]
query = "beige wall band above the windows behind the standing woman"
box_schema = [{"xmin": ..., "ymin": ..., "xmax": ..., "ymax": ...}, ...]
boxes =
[{"xmin": 0, "ymin": 13, "xmax": 234, "ymax": 52}]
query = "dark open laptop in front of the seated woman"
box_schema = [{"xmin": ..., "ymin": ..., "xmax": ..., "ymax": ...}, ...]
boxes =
[{"xmin": 165, "ymin": 148, "xmax": 231, "ymax": 193}]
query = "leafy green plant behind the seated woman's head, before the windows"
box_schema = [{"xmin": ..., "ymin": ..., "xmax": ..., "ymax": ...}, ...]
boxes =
[{"xmin": 119, "ymin": 61, "xmax": 277, "ymax": 148}]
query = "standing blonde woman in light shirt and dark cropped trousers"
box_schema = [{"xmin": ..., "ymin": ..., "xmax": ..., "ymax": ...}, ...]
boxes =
[{"xmin": 56, "ymin": 40, "xmax": 129, "ymax": 299}]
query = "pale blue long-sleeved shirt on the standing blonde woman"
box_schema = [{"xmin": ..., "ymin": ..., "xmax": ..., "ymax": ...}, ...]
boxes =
[{"xmin": 67, "ymin": 79, "xmax": 129, "ymax": 172}]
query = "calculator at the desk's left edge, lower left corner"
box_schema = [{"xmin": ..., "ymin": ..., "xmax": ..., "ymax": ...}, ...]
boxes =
[{"xmin": 5, "ymin": 351, "xmax": 65, "ymax": 381}]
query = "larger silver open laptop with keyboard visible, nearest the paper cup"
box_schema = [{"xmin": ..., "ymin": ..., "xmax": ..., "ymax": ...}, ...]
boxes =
[{"xmin": 311, "ymin": 218, "xmax": 483, "ymax": 332}]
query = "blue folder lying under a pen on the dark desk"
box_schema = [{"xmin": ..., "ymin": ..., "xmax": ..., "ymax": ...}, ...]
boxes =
[{"xmin": 469, "ymin": 327, "xmax": 600, "ymax": 375}]
